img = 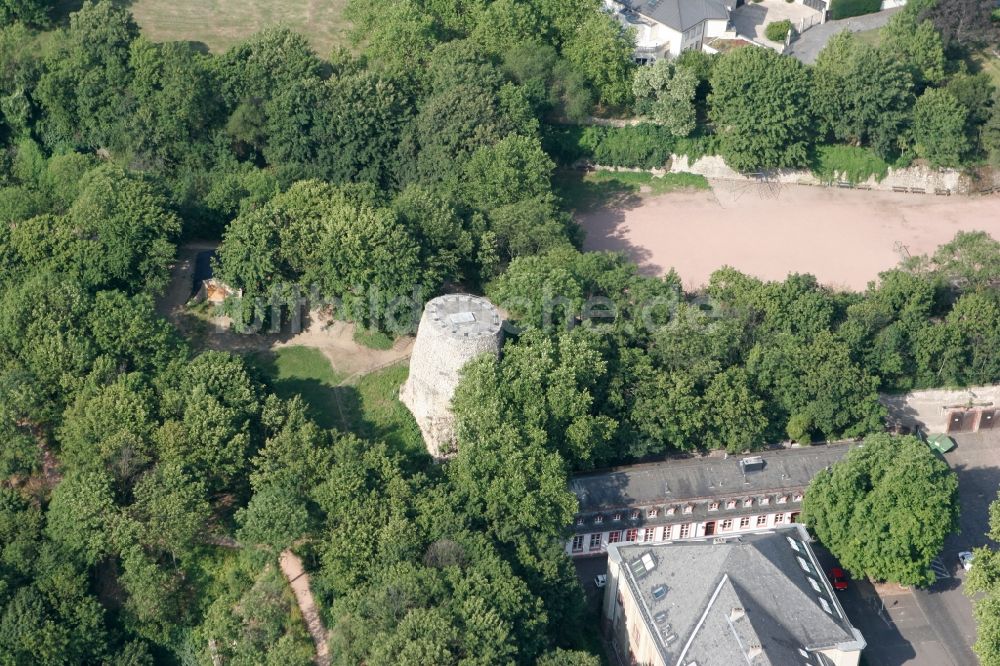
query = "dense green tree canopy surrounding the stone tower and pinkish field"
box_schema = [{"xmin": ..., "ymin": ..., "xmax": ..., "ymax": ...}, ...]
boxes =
[{"xmin": 0, "ymin": 0, "xmax": 1000, "ymax": 666}]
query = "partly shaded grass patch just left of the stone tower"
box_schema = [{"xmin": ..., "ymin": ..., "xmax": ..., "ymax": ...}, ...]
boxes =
[{"xmin": 249, "ymin": 346, "xmax": 428, "ymax": 467}]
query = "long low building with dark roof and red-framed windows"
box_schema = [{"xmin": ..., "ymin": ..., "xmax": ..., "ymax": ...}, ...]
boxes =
[{"xmin": 566, "ymin": 444, "xmax": 858, "ymax": 557}]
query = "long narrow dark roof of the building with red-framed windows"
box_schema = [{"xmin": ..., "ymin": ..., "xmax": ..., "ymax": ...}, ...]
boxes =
[{"xmin": 570, "ymin": 444, "xmax": 856, "ymax": 514}]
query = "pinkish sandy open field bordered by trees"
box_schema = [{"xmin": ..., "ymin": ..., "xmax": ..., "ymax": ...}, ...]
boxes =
[{"xmin": 578, "ymin": 181, "xmax": 1000, "ymax": 290}]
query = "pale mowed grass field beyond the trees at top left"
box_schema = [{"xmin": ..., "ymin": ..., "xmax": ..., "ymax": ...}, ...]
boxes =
[{"xmin": 129, "ymin": 0, "xmax": 349, "ymax": 58}]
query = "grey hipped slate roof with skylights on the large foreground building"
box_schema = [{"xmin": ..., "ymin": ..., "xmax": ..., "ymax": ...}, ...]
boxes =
[{"xmin": 608, "ymin": 526, "xmax": 864, "ymax": 666}]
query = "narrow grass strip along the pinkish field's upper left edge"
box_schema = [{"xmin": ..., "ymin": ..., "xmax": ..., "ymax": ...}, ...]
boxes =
[{"xmin": 553, "ymin": 170, "xmax": 710, "ymax": 212}]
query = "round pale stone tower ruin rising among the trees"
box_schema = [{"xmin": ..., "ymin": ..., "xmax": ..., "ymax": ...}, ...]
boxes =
[{"xmin": 399, "ymin": 294, "xmax": 503, "ymax": 458}]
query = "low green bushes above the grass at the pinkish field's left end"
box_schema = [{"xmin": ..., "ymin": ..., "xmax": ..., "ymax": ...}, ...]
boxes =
[{"xmin": 542, "ymin": 124, "xmax": 674, "ymax": 169}]
